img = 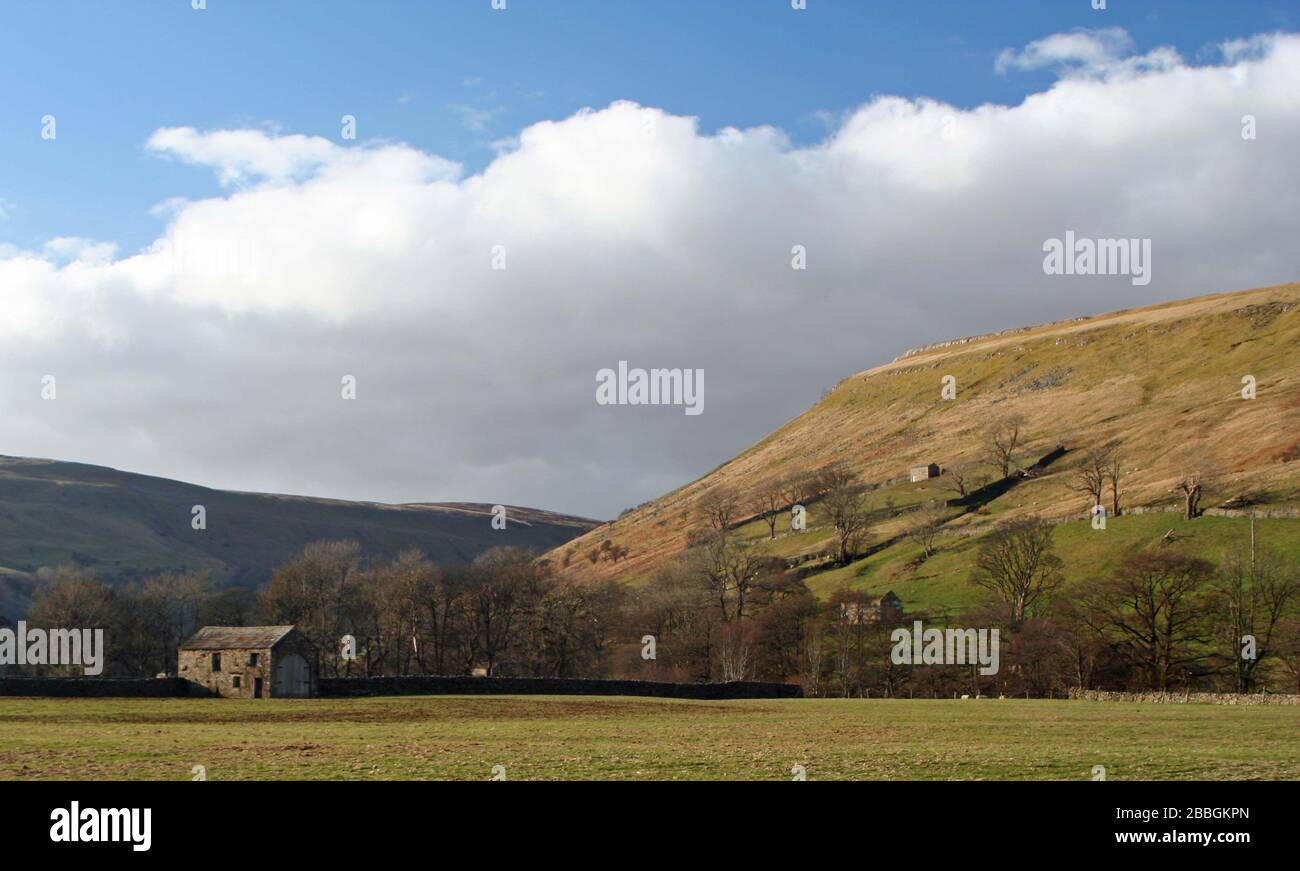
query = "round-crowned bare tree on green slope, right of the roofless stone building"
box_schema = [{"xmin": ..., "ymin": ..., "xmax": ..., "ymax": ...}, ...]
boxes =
[{"xmin": 971, "ymin": 517, "xmax": 1062, "ymax": 629}]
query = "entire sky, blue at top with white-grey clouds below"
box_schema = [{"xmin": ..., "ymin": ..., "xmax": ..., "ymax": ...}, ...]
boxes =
[{"xmin": 0, "ymin": 0, "xmax": 1300, "ymax": 517}]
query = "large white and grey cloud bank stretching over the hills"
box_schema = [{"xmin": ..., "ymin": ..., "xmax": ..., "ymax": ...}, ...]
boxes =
[{"xmin": 0, "ymin": 34, "xmax": 1300, "ymax": 515}]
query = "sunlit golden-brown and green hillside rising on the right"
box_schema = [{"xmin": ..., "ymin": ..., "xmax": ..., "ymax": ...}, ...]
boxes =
[{"xmin": 551, "ymin": 285, "xmax": 1300, "ymax": 607}]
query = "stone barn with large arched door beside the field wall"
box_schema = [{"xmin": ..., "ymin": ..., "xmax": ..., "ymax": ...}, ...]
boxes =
[{"xmin": 177, "ymin": 627, "xmax": 320, "ymax": 698}]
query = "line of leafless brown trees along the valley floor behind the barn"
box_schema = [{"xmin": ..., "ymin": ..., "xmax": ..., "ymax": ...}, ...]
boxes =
[{"xmin": 9, "ymin": 444, "xmax": 1300, "ymax": 697}]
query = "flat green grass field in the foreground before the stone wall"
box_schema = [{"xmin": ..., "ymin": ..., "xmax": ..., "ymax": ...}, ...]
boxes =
[{"xmin": 0, "ymin": 697, "xmax": 1300, "ymax": 780}]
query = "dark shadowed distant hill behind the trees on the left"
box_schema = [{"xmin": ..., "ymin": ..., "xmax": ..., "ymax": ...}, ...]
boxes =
[{"xmin": 0, "ymin": 456, "xmax": 595, "ymax": 612}]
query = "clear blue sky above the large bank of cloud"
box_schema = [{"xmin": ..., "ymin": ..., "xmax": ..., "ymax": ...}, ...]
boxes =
[{"xmin": 0, "ymin": 0, "xmax": 1300, "ymax": 254}]
